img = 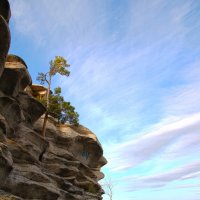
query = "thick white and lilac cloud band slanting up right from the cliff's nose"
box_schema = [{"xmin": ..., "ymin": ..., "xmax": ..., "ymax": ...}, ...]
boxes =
[{"xmin": 105, "ymin": 114, "xmax": 200, "ymax": 170}]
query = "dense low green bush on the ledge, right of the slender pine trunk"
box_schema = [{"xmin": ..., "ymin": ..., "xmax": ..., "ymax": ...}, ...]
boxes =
[{"xmin": 48, "ymin": 87, "xmax": 79, "ymax": 125}]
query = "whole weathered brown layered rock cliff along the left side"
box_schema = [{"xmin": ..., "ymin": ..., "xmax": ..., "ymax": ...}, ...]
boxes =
[{"xmin": 0, "ymin": 0, "xmax": 106, "ymax": 200}]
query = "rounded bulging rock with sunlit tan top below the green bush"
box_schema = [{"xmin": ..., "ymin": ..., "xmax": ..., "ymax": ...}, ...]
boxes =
[{"xmin": 58, "ymin": 125, "xmax": 107, "ymax": 168}]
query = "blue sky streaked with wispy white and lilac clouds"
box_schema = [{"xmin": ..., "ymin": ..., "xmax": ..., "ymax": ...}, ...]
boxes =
[{"xmin": 10, "ymin": 0, "xmax": 200, "ymax": 200}]
